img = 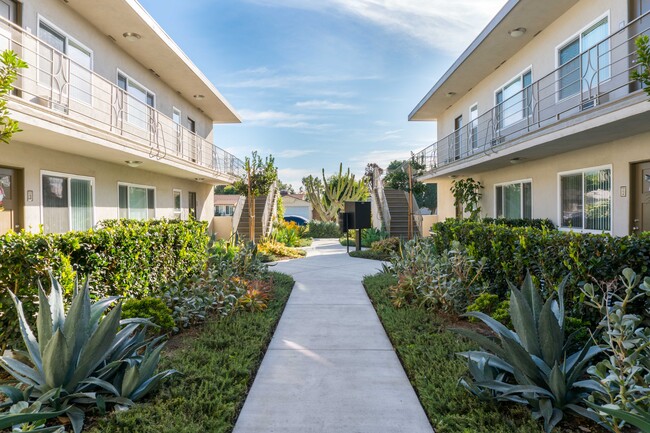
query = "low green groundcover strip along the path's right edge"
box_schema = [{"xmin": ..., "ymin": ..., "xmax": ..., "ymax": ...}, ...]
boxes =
[{"xmin": 364, "ymin": 274, "xmax": 603, "ymax": 433}]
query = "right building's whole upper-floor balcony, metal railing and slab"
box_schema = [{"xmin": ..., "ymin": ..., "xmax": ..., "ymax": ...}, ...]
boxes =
[{"xmin": 414, "ymin": 14, "xmax": 650, "ymax": 177}]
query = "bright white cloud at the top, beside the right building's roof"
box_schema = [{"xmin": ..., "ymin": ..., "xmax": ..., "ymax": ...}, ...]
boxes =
[{"xmin": 240, "ymin": 0, "xmax": 506, "ymax": 54}]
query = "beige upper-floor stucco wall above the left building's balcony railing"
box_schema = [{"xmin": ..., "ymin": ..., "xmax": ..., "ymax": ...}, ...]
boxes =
[{"xmin": 22, "ymin": 0, "xmax": 213, "ymax": 139}]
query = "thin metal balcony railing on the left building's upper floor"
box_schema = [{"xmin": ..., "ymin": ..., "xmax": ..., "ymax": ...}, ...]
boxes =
[{"xmin": 0, "ymin": 18, "xmax": 244, "ymax": 178}]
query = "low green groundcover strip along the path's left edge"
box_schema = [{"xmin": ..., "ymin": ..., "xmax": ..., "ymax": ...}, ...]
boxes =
[{"xmin": 89, "ymin": 273, "xmax": 294, "ymax": 433}]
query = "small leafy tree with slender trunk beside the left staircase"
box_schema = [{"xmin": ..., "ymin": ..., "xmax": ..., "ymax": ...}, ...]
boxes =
[{"xmin": 233, "ymin": 151, "xmax": 278, "ymax": 242}]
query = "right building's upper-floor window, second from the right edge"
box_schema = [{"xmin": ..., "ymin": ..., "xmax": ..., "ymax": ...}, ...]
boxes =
[{"xmin": 495, "ymin": 70, "xmax": 533, "ymax": 129}]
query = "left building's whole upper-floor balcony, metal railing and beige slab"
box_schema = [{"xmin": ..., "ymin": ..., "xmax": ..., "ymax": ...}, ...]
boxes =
[{"xmin": 0, "ymin": 19, "xmax": 243, "ymax": 183}]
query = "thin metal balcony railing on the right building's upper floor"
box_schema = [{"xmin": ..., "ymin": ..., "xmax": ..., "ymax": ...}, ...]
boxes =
[{"xmin": 414, "ymin": 13, "xmax": 650, "ymax": 173}]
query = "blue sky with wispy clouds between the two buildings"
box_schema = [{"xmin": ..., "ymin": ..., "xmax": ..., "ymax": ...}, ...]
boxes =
[{"xmin": 140, "ymin": 0, "xmax": 506, "ymax": 189}]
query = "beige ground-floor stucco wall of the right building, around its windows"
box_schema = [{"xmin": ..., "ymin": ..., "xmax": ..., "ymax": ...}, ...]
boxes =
[{"xmin": 429, "ymin": 133, "xmax": 650, "ymax": 236}]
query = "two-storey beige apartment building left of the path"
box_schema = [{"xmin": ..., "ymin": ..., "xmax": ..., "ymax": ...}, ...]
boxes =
[{"xmin": 0, "ymin": 0, "xmax": 241, "ymax": 233}]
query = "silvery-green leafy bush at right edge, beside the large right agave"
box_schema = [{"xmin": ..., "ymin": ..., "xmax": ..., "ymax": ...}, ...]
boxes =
[{"xmin": 582, "ymin": 268, "xmax": 650, "ymax": 433}]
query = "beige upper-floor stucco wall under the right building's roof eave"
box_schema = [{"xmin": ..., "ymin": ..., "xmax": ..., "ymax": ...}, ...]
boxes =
[{"xmin": 437, "ymin": 0, "xmax": 628, "ymax": 140}]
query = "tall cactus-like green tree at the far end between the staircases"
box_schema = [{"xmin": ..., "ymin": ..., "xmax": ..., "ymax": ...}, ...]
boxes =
[{"xmin": 302, "ymin": 163, "xmax": 369, "ymax": 221}]
